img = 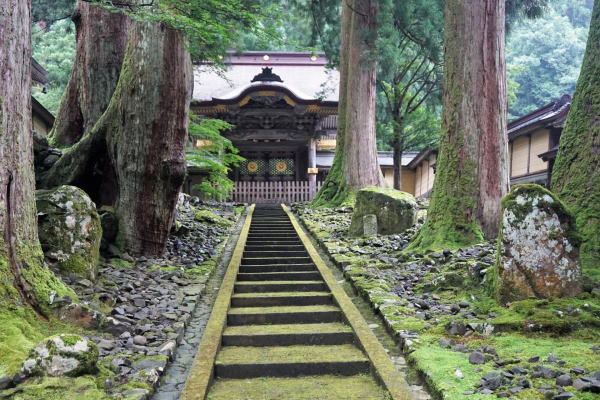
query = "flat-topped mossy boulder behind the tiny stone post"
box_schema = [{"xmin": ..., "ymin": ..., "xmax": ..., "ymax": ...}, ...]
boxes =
[{"xmin": 349, "ymin": 187, "xmax": 418, "ymax": 236}]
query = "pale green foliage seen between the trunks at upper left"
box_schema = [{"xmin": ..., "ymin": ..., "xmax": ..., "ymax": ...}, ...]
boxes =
[{"xmin": 31, "ymin": 20, "xmax": 75, "ymax": 113}]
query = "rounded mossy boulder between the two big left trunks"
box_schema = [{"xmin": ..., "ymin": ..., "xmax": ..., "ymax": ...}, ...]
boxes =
[{"xmin": 36, "ymin": 186, "xmax": 102, "ymax": 280}]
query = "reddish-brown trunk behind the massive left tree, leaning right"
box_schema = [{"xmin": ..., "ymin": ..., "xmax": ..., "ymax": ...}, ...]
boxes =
[{"xmin": 50, "ymin": 0, "xmax": 130, "ymax": 146}]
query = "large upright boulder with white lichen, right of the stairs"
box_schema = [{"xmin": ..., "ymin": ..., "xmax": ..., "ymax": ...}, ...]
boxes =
[{"xmin": 495, "ymin": 185, "xmax": 581, "ymax": 303}]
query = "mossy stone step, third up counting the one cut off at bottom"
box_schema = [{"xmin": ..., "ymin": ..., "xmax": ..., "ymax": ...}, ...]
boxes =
[{"xmin": 222, "ymin": 322, "xmax": 355, "ymax": 346}]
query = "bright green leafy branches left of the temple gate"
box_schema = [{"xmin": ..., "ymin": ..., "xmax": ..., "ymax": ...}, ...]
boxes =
[{"xmin": 187, "ymin": 119, "xmax": 244, "ymax": 197}]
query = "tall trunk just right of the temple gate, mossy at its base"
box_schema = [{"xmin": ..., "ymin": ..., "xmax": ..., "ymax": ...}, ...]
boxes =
[{"xmin": 313, "ymin": 0, "xmax": 383, "ymax": 206}]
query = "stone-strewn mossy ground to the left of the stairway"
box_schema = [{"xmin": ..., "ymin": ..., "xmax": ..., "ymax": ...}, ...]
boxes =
[{"xmin": 0, "ymin": 197, "xmax": 243, "ymax": 400}]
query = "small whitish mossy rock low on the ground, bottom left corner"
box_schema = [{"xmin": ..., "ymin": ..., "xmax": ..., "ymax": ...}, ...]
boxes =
[{"xmin": 22, "ymin": 334, "xmax": 98, "ymax": 377}]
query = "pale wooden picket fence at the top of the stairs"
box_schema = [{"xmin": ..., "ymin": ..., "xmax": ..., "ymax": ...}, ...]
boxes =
[{"xmin": 230, "ymin": 181, "xmax": 322, "ymax": 204}]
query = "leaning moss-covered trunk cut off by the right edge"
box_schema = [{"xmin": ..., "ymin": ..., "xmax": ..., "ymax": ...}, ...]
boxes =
[{"xmin": 551, "ymin": 0, "xmax": 600, "ymax": 280}]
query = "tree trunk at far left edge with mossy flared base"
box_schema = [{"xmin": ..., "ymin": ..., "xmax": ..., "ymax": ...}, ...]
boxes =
[{"xmin": 0, "ymin": 0, "xmax": 73, "ymax": 315}]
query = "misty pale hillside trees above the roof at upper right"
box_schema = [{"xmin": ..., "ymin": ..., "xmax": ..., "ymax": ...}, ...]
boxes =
[{"xmin": 506, "ymin": 0, "xmax": 591, "ymax": 118}]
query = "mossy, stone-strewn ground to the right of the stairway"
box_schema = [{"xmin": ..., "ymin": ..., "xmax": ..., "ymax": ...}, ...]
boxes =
[{"xmin": 294, "ymin": 205, "xmax": 600, "ymax": 400}]
